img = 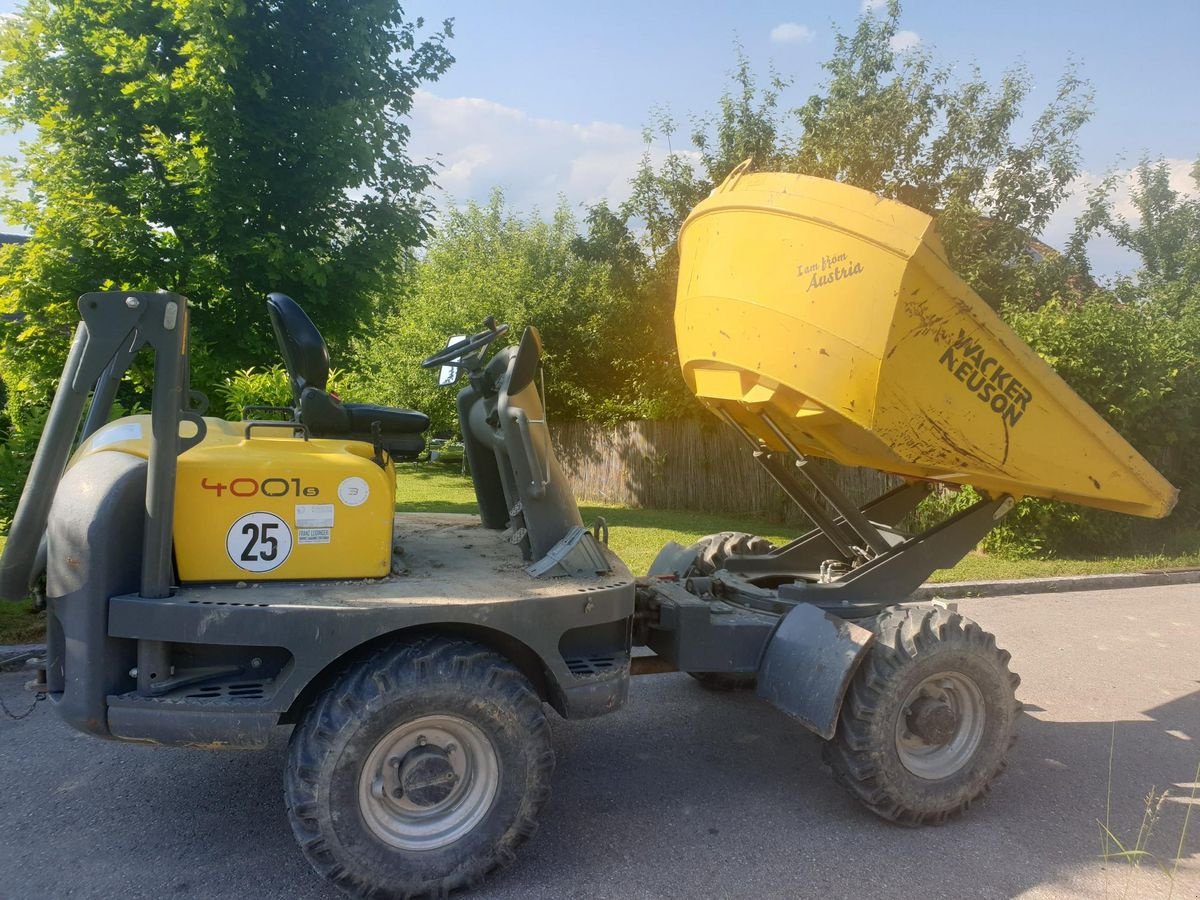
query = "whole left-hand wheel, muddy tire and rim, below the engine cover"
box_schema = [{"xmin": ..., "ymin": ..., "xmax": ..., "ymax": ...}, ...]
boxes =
[{"xmin": 286, "ymin": 637, "xmax": 554, "ymax": 898}]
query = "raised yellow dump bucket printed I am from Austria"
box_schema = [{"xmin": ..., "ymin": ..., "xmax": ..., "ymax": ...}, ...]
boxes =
[{"xmin": 676, "ymin": 172, "xmax": 1176, "ymax": 517}]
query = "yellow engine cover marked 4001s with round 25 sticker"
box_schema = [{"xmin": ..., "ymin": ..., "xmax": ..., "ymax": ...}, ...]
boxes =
[{"xmin": 78, "ymin": 415, "xmax": 396, "ymax": 582}]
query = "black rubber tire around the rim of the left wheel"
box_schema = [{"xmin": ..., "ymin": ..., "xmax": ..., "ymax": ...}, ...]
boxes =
[{"xmin": 286, "ymin": 637, "xmax": 554, "ymax": 899}]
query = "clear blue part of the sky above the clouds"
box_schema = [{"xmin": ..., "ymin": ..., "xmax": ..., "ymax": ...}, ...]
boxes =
[{"xmin": 434, "ymin": 0, "xmax": 1200, "ymax": 168}]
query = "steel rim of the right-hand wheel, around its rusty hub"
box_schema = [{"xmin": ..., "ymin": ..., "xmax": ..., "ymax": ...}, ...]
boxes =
[{"xmin": 896, "ymin": 672, "xmax": 988, "ymax": 781}]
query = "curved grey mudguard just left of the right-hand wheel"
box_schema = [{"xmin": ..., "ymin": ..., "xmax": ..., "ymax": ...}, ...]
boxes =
[{"xmin": 757, "ymin": 604, "xmax": 875, "ymax": 740}]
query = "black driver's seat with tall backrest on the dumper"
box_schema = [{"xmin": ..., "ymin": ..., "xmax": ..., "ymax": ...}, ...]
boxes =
[{"xmin": 266, "ymin": 293, "xmax": 430, "ymax": 460}]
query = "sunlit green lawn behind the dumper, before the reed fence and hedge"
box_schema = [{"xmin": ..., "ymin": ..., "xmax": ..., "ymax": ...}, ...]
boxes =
[{"xmin": 396, "ymin": 464, "xmax": 1200, "ymax": 582}]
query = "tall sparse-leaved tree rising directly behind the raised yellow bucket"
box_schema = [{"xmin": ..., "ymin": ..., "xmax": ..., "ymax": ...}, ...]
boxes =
[{"xmin": 787, "ymin": 0, "xmax": 1091, "ymax": 308}]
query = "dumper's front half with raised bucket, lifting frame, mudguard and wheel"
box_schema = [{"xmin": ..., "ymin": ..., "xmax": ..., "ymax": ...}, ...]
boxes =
[{"xmin": 646, "ymin": 164, "xmax": 1176, "ymax": 824}]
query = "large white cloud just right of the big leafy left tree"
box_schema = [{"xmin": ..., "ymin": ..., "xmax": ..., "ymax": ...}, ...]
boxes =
[{"xmin": 409, "ymin": 90, "xmax": 686, "ymax": 212}]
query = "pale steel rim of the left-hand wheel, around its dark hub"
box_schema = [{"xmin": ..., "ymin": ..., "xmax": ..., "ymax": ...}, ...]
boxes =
[{"xmin": 359, "ymin": 715, "xmax": 500, "ymax": 851}]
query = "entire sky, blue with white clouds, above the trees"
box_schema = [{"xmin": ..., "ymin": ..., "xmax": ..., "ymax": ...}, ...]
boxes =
[{"xmin": 0, "ymin": 0, "xmax": 1200, "ymax": 271}]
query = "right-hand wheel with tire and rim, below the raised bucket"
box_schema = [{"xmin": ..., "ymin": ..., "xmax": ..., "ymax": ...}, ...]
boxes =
[{"xmin": 824, "ymin": 607, "xmax": 1020, "ymax": 826}]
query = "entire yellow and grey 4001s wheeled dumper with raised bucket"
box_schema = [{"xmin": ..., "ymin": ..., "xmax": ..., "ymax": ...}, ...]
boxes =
[{"xmin": 0, "ymin": 173, "xmax": 1174, "ymax": 896}]
